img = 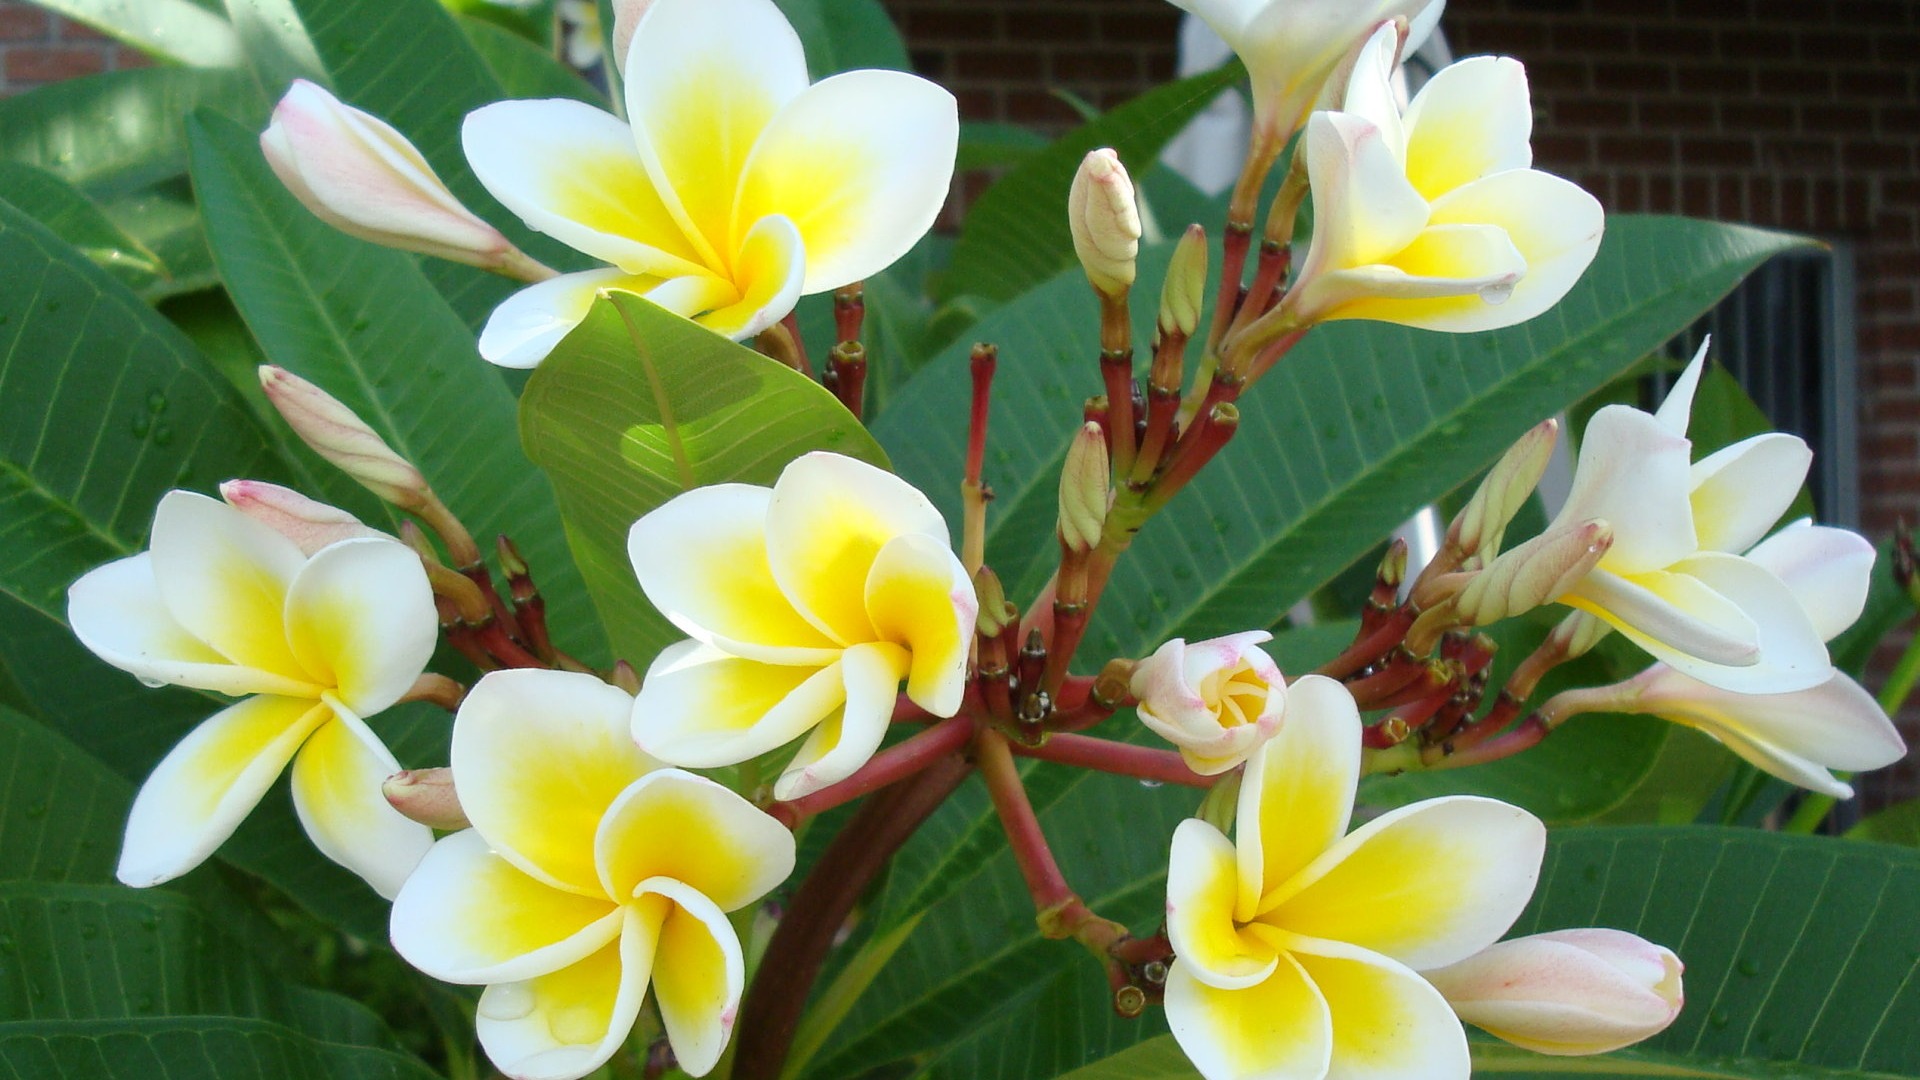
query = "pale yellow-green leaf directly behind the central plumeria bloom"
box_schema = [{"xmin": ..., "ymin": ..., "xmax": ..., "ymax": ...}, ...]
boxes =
[{"xmin": 520, "ymin": 292, "xmax": 887, "ymax": 669}]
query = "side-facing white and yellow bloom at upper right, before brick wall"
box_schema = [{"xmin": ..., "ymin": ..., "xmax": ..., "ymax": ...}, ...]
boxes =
[{"xmin": 1286, "ymin": 27, "xmax": 1605, "ymax": 332}]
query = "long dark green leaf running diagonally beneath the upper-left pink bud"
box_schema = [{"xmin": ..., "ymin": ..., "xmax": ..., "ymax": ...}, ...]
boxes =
[{"xmin": 192, "ymin": 117, "xmax": 605, "ymax": 657}]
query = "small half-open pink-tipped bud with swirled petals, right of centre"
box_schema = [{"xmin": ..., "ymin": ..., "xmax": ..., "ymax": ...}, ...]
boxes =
[{"xmin": 1129, "ymin": 630, "xmax": 1286, "ymax": 776}]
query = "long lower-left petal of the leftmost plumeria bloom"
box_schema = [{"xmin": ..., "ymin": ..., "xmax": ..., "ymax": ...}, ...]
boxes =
[{"xmin": 115, "ymin": 694, "xmax": 332, "ymax": 888}]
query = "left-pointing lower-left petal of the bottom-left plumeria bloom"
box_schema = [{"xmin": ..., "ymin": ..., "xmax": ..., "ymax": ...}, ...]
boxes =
[{"xmin": 392, "ymin": 828, "xmax": 624, "ymax": 986}]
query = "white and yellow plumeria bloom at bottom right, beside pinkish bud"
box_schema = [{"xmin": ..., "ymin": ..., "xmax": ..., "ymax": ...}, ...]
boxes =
[{"xmin": 1167, "ymin": 675, "xmax": 1546, "ymax": 1080}]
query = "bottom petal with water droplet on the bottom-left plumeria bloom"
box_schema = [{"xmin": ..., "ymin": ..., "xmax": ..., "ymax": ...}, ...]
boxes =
[{"xmin": 474, "ymin": 901, "xmax": 666, "ymax": 1080}]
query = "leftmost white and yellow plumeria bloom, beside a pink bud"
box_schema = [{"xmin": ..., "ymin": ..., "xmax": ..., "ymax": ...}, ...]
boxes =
[{"xmin": 67, "ymin": 492, "xmax": 440, "ymax": 896}]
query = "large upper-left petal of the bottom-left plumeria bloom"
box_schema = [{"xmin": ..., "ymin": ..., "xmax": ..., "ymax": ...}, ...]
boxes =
[{"xmin": 451, "ymin": 669, "xmax": 659, "ymax": 897}]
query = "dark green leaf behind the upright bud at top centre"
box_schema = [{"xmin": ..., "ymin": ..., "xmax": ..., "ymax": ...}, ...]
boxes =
[{"xmin": 941, "ymin": 63, "xmax": 1244, "ymax": 303}]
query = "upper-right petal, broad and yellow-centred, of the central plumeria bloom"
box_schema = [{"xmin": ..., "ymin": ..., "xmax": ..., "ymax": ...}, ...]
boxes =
[{"xmin": 766, "ymin": 452, "xmax": 950, "ymax": 646}]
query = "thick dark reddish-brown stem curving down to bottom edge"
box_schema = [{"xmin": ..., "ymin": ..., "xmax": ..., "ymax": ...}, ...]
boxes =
[{"xmin": 733, "ymin": 755, "xmax": 972, "ymax": 1080}]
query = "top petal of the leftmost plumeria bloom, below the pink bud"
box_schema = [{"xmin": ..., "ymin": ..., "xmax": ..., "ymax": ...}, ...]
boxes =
[{"xmin": 152, "ymin": 492, "xmax": 311, "ymax": 680}]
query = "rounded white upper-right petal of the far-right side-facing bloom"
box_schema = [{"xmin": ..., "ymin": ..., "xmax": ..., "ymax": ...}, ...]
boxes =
[{"xmin": 1692, "ymin": 432, "xmax": 1812, "ymax": 555}]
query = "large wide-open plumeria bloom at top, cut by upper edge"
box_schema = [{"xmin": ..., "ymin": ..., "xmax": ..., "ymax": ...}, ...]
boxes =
[{"xmin": 463, "ymin": 0, "xmax": 960, "ymax": 367}]
